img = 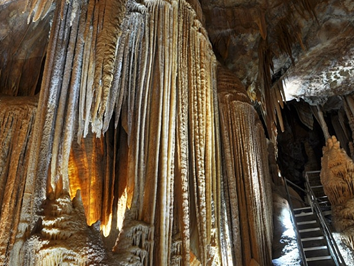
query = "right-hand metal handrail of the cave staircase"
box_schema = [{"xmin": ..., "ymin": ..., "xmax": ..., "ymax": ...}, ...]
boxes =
[{"xmin": 306, "ymin": 171, "xmax": 346, "ymax": 266}]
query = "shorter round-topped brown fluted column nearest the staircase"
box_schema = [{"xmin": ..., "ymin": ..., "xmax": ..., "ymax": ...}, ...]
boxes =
[{"xmin": 218, "ymin": 65, "xmax": 273, "ymax": 265}]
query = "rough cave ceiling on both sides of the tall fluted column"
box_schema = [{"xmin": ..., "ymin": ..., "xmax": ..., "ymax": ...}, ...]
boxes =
[{"xmin": 0, "ymin": 0, "xmax": 354, "ymax": 104}]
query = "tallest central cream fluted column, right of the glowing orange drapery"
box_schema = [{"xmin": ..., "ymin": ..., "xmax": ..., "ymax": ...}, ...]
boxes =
[{"xmin": 109, "ymin": 1, "xmax": 220, "ymax": 265}]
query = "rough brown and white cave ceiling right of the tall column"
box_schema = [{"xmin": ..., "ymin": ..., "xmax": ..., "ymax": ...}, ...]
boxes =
[{"xmin": 202, "ymin": 0, "xmax": 354, "ymax": 104}]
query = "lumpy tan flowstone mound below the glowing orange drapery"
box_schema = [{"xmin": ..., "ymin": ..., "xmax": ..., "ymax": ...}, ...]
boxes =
[{"xmin": 21, "ymin": 191, "xmax": 106, "ymax": 266}]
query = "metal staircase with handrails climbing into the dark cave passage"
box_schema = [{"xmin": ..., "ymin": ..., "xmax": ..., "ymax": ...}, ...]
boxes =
[{"xmin": 284, "ymin": 171, "xmax": 346, "ymax": 266}]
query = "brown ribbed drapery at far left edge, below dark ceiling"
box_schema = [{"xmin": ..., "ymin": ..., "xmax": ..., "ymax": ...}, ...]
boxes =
[{"xmin": 0, "ymin": 97, "xmax": 38, "ymax": 264}]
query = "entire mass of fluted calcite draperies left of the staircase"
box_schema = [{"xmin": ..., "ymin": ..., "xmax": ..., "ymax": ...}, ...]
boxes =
[{"xmin": 0, "ymin": 0, "xmax": 272, "ymax": 265}]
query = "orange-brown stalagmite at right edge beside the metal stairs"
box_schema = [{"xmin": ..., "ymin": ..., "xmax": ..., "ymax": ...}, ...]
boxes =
[{"xmin": 321, "ymin": 136, "xmax": 354, "ymax": 249}]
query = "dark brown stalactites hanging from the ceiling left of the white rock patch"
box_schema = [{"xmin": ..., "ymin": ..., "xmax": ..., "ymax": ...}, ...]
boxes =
[{"xmin": 256, "ymin": 0, "xmax": 317, "ymax": 140}]
